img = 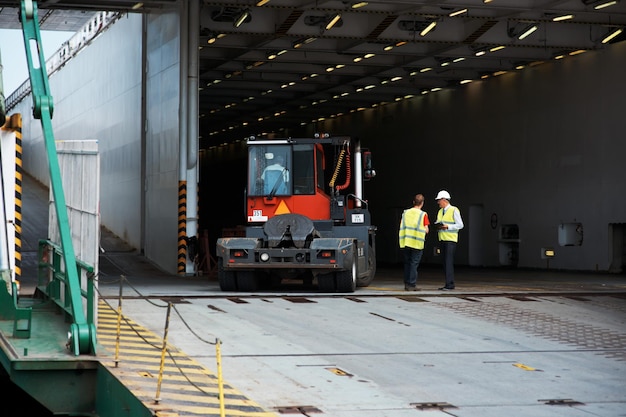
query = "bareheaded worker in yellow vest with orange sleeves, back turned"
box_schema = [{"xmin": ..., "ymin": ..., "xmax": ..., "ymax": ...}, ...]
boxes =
[{"xmin": 398, "ymin": 194, "xmax": 430, "ymax": 291}]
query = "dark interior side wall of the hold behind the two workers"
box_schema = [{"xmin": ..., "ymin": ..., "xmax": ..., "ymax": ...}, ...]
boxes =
[{"xmin": 317, "ymin": 42, "xmax": 626, "ymax": 270}]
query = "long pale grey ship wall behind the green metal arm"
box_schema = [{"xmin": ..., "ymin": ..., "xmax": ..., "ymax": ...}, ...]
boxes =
[{"xmin": 17, "ymin": 15, "xmax": 141, "ymax": 252}]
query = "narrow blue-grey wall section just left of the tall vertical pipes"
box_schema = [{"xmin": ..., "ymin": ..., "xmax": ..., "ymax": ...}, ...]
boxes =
[{"xmin": 144, "ymin": 13, "xmax": 180, "ymax": 273}]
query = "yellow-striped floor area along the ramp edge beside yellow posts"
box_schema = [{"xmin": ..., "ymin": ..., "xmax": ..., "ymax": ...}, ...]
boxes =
[{"xmin": 97, "ymin": 300, "xmax": 276, "ymax": 417}]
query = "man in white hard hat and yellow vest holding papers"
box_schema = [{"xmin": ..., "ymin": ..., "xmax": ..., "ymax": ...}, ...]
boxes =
[{"xmin": 435, "ymin": 190, "xmax": 464, "ymax": 291}]
